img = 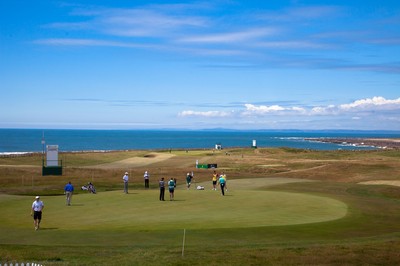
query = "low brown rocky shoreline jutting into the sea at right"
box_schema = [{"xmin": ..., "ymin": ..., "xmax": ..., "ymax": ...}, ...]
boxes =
[{"xmin": 305, "ymin": 138, "xmax": 400, "ymax": 149}]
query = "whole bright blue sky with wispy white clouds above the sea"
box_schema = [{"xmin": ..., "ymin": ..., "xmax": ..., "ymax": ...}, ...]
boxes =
[{"xmin": 0, "ymin": 0, "xmax": 400, "ymax": 130}]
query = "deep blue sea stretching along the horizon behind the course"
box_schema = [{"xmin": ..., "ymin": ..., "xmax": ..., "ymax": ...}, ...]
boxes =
[{"xmin": 0, "ymin": 129, "xmax": 400, "ymax": 155}]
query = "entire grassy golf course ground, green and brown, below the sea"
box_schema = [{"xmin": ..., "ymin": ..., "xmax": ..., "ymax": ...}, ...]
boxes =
[{"xmin": 0, "ymin": 148, "xmax": 400, "ymax": 265}]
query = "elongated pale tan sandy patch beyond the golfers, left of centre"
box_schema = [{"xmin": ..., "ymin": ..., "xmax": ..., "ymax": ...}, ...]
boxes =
[{"xmin": 94, "ymin": 152, "xmax": 175, "ymax": 168}]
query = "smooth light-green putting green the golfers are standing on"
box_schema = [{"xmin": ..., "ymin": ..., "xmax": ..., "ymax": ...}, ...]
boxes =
[{"xmin": 0, "ymin": 178, "xmax": 347, "ymax": 244}]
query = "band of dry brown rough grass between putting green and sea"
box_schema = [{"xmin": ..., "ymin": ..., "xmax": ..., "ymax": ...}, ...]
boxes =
[{"xmin": 0, "ymin": 148, "xmax": 400, "ymax": 194}]
